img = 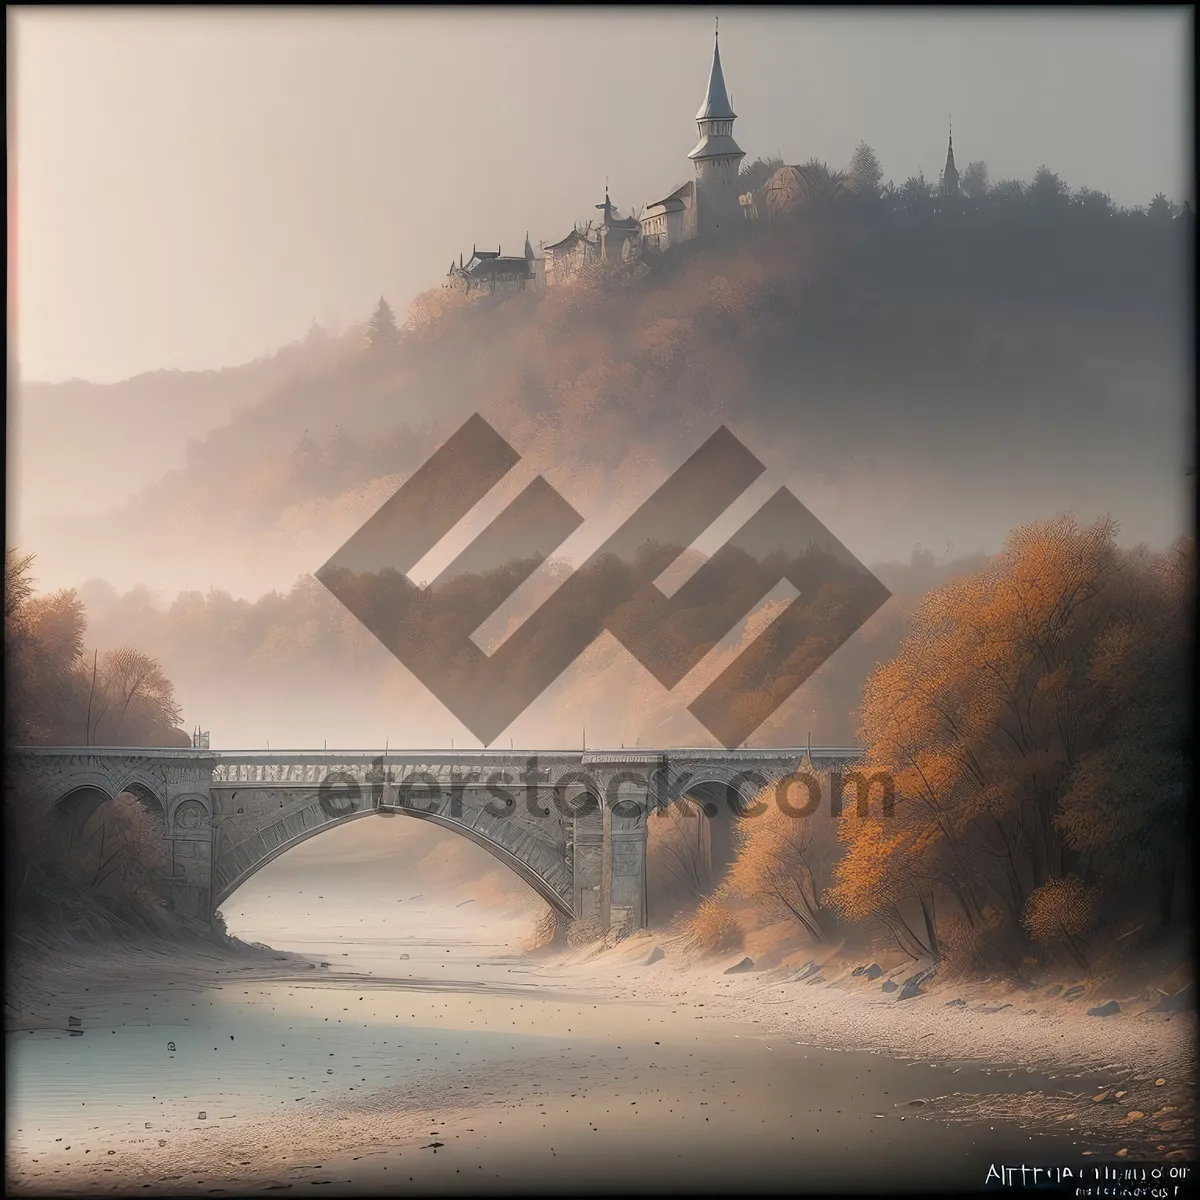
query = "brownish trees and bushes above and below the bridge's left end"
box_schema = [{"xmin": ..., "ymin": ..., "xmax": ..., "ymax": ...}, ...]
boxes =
[{"xmin": 4, "ymin": 547, "xmax": 191, "ymax": 947}]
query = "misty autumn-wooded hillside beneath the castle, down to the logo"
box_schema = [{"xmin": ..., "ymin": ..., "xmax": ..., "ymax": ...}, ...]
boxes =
[{"xmin": 16, "ymin": 169, "xmax": 1190, "ymax": 594}]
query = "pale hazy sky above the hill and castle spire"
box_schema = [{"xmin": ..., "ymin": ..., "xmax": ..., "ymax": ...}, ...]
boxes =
[{"xmin": 8, "ymin": 7, "xmax": 1192, "ymax": 380}]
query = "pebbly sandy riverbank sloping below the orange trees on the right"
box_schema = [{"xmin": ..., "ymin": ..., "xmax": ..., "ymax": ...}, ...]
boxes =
[{"xmin": 546, "ymin": 934, "xmax": 1196, "ymax": 1160}]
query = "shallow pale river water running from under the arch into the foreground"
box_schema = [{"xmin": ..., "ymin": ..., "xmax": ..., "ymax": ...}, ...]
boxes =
[{"xmin": 8, "ymin": 881, "xmax": 1113, "ymax": 1193}]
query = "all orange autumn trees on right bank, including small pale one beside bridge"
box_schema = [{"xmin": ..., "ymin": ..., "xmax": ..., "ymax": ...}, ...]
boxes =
[{"xmin": 700, "ymin": 517, "xmax": 1194, "ymax": 974}]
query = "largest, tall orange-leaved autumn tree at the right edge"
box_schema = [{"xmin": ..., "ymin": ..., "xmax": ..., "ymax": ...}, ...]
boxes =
[{"xmin": 834, "ymin": 517, "xmax": 1190, "ymax": 969}]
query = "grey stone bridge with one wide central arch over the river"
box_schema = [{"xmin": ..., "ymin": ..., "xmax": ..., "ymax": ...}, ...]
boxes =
[{"xmin": 4, "ymin": 748, "xmax": 859, "ymax": 932}]
